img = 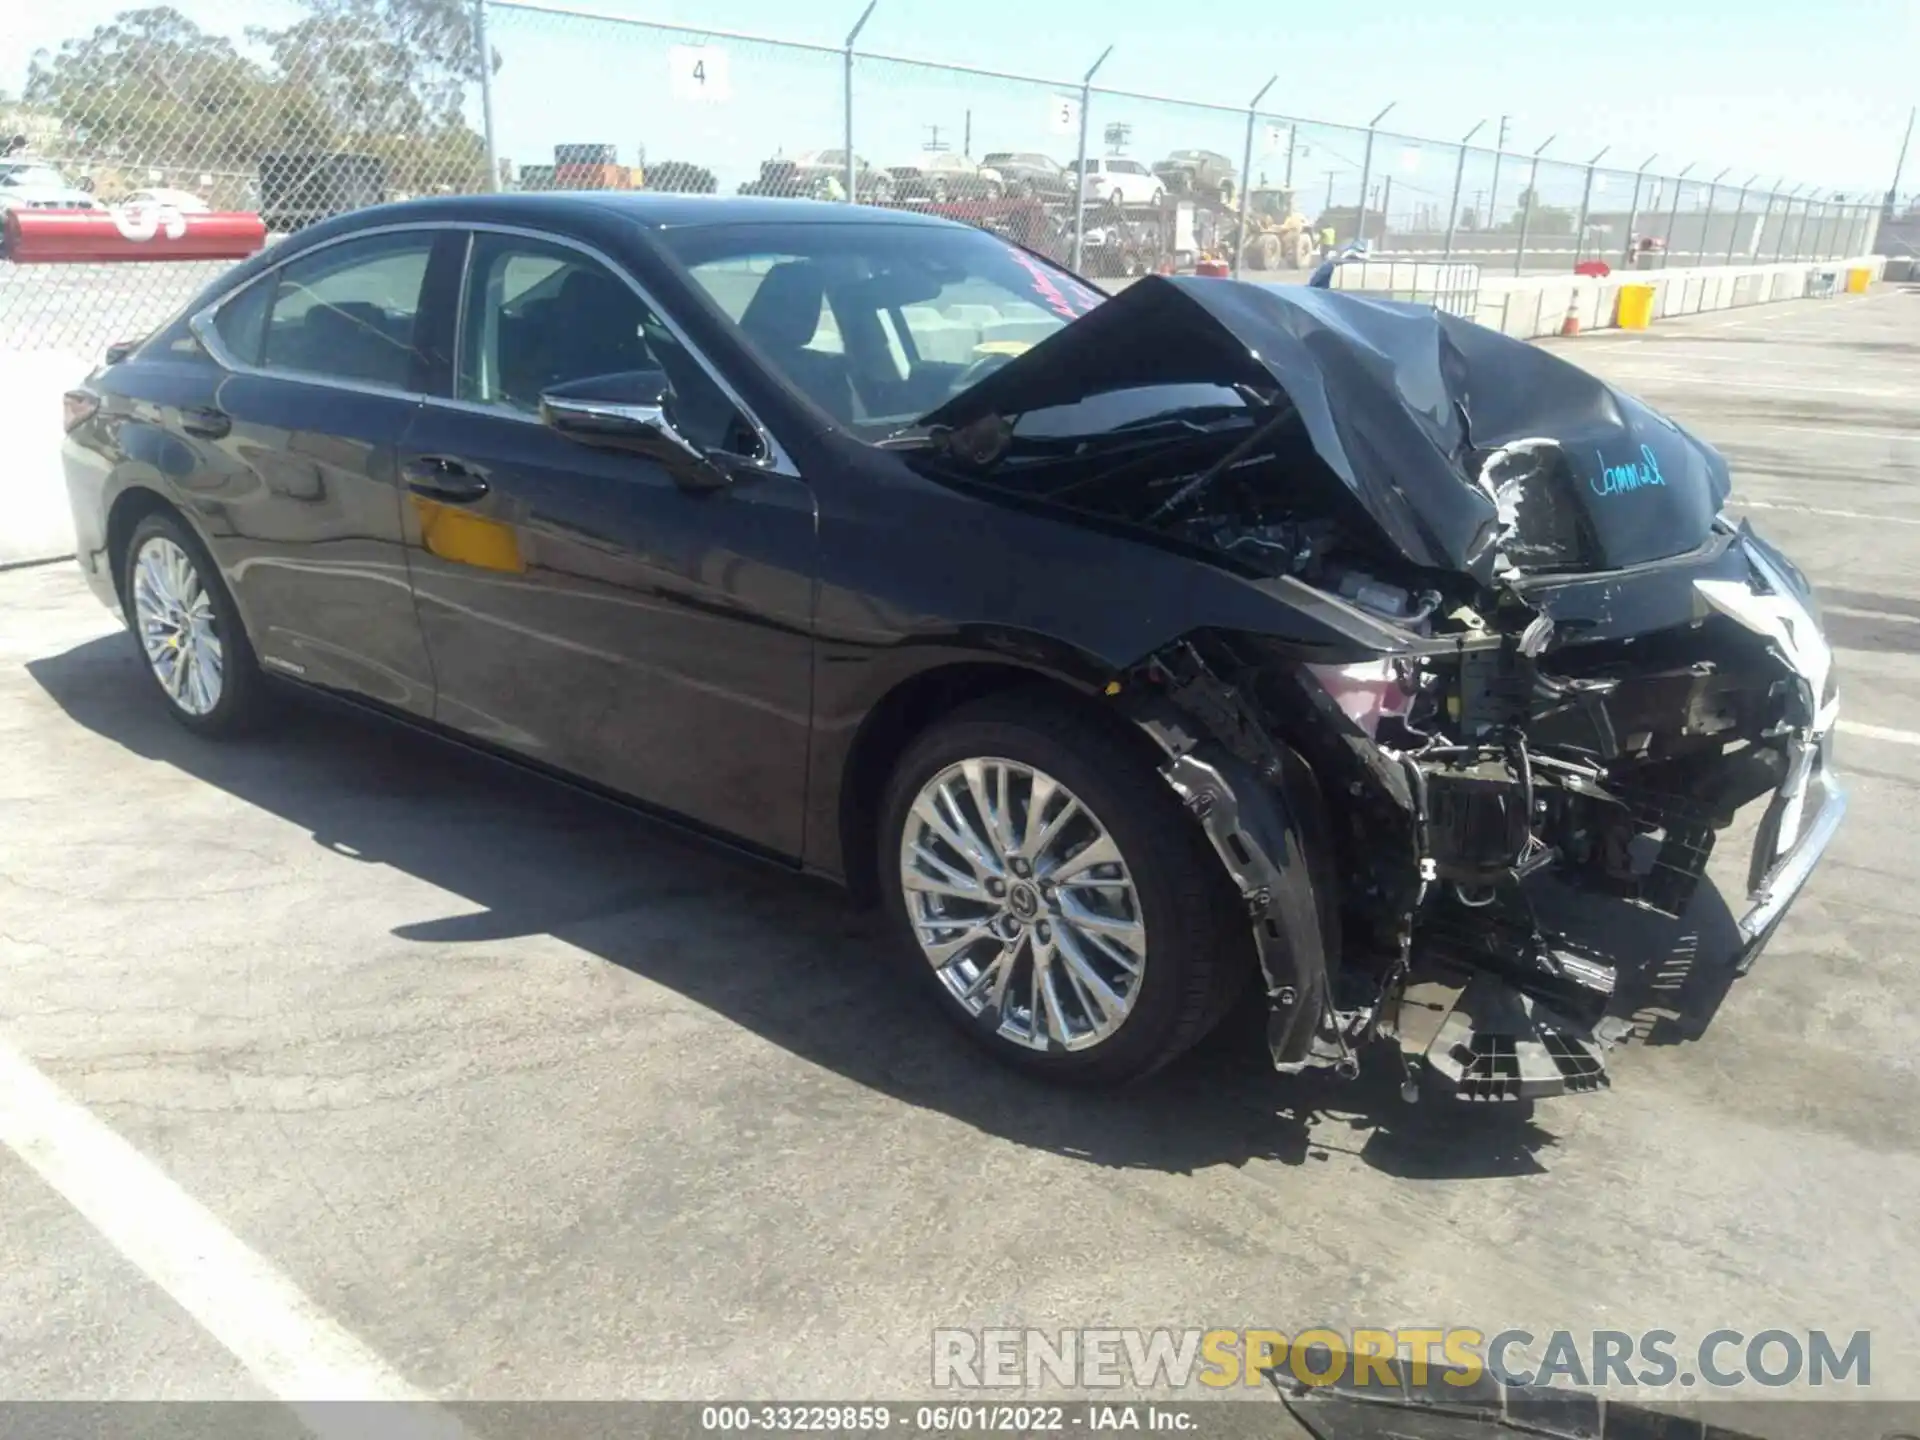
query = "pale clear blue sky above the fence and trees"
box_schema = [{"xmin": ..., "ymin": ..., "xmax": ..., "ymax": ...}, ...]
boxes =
[{"xmin": 0, "ymin": 0, "xmax": 1920, "ymax": 211}]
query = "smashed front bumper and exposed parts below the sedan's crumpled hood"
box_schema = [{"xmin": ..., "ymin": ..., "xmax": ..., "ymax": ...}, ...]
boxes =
[{"xmin": 1135, "ymin": 540, "xmax": 1847, "ymax": 1100}]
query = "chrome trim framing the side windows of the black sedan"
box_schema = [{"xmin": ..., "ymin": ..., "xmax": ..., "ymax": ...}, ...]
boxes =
[{"xmin": 188, "ymin": 219, "xmax": 801, "ymax": 480}]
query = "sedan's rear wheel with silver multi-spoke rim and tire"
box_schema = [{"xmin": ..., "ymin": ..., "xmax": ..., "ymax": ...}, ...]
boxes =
[{"xmin": 121, "ymin": 513, "xmax": 265, "ymax": 735}]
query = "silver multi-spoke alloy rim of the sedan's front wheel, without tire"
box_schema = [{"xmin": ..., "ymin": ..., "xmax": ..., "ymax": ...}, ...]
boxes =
[{"xmin": 900, "ymin": 756, "xmax": 1146, "ymax": 1050}]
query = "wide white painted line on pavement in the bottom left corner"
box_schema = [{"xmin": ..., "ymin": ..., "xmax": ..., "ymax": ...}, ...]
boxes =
[{"xmin": 0, "ymin": 1039, "xmax": 465, "ymax": 1440}]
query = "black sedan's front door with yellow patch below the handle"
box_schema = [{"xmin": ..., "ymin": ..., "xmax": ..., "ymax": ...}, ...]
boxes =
[{"xmin": 399, "ymin": 228, "xmax": 814, "ymax": 856}]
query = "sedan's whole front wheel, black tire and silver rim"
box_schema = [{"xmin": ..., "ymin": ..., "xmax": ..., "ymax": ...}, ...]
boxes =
[{"xmin": 879, "ymin": 691, "xmax": 1254, "ymax": 1085}]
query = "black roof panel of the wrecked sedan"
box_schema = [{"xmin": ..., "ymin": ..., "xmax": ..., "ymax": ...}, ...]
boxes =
[{"xmin": 312, "ymin": 190, "xmax": 954, "ymax": 230}]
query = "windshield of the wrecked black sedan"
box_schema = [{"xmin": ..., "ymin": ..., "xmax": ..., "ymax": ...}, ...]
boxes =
[{"xmin": 659, "ymin": 223, "xmax": 1104, "ymax": 444}]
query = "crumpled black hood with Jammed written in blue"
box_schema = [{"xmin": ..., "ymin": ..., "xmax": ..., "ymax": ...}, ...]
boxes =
[{"xmin": 924, "ymin": 276, "xmax": 1730, "ymax": 584}]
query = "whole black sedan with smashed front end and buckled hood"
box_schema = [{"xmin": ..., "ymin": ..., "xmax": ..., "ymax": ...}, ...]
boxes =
[{"xmin": 63, "ymin": 194, "xmax": 1845, "ymax": 1098}]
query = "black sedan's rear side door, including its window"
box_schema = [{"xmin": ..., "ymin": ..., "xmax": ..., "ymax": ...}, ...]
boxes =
[{"xmin": 182, "ymin": 228, "xmax": 465, "ymax": 716}]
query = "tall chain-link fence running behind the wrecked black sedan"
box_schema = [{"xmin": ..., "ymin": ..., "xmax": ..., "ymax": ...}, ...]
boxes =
[{"xmin": 0, "ymin": 0, "xmax": 1882, "ymax": 355}]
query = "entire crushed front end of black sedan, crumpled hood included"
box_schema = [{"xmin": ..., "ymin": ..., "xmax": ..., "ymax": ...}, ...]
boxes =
[{"xmin": 910, "ymin": 272, "xmax": 1845, "ymax": 1100}]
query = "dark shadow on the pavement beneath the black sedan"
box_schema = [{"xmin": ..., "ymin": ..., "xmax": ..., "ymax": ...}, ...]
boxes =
[{"xmin": 27, "ymin": 636, "xmax": 1555, "ymax": 1179}]
